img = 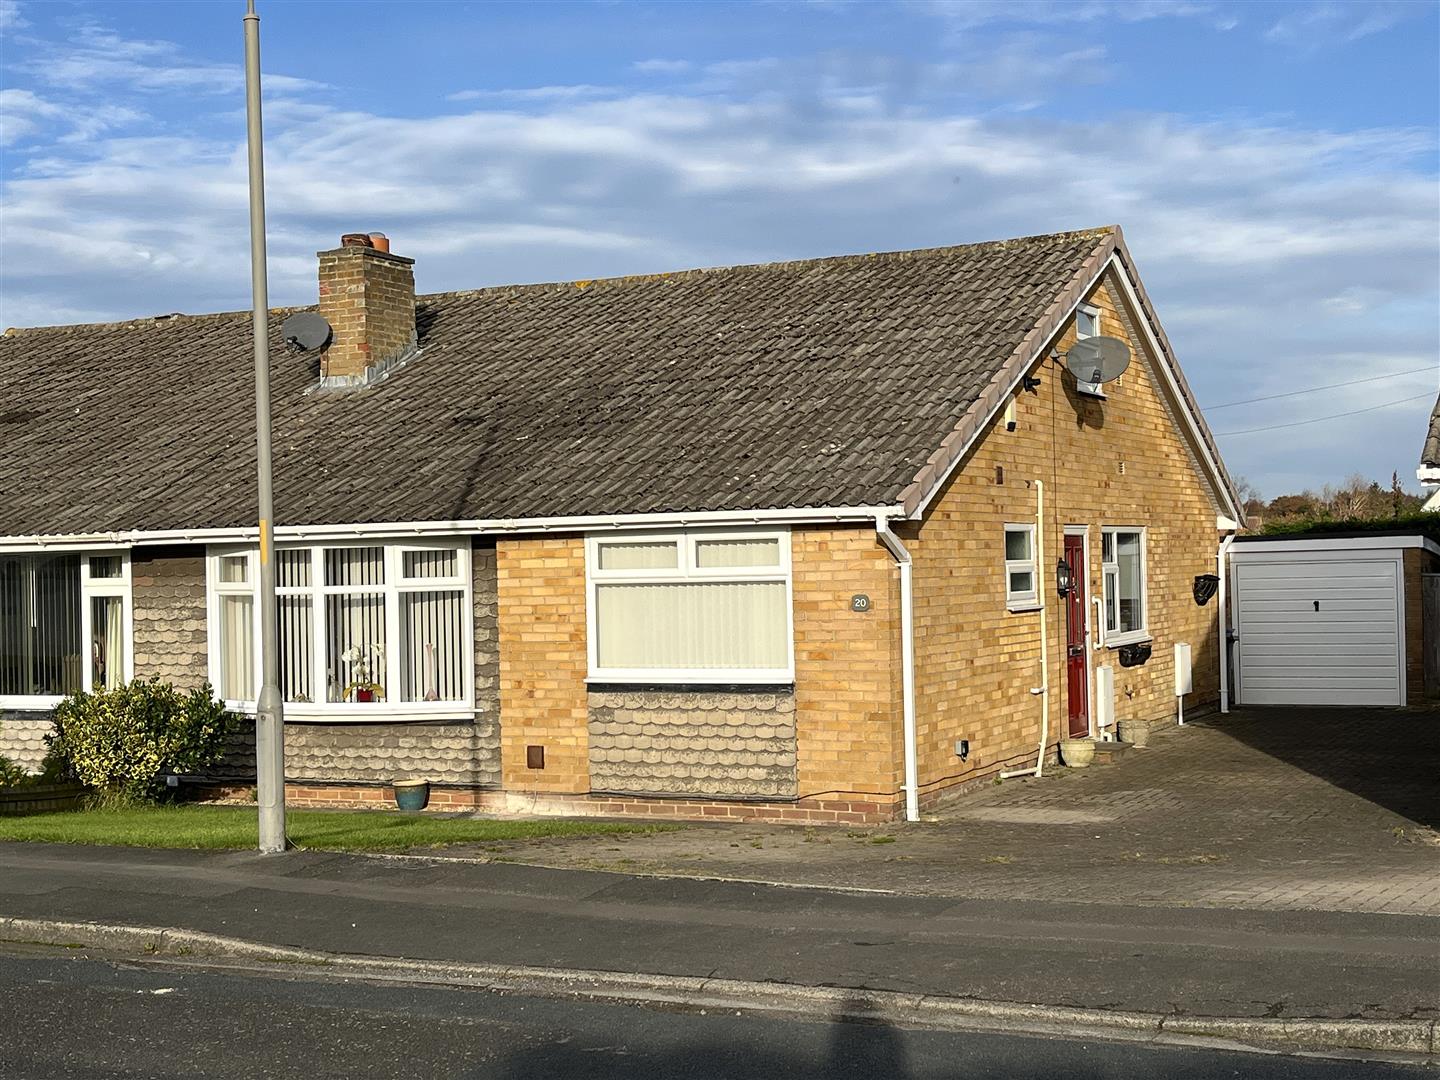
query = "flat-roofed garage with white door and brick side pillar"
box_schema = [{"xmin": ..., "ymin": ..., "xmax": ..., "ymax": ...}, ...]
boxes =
[{"xmin": 1230, "ymin": 534, "xmax": 1440, "ymax": 706}]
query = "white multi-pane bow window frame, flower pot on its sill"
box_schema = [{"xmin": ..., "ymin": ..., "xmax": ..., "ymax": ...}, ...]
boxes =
[{"xmin": 204, "ymin": 536, "xmax": 475, "ymax": 724}]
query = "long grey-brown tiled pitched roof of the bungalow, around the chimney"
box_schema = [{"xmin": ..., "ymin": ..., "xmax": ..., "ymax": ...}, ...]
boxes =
[{"xmin": 0, "ymin": 228, "xmax": 1228, "ymax": 537}]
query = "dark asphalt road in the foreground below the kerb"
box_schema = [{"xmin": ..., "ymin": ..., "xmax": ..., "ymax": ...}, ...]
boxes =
[{"xmin": 0, "ymin": 945, "xmax": 1434, "ymax": 1080}]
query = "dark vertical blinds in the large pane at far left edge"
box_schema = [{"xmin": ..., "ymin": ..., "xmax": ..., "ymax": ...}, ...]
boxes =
[{"xmin": 0, "ymin": 554, "xmax": 84, "ymax": 696}]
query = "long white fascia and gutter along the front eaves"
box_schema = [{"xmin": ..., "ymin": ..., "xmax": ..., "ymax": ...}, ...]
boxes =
[{"xmin": 0, "ymin": 505, "xmax": 904, "ymax": 552}]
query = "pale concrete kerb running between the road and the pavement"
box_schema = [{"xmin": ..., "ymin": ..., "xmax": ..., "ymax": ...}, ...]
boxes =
[{"xmin": 0, "ymin": 917, "xmax": 1440, "ymax": 1063}]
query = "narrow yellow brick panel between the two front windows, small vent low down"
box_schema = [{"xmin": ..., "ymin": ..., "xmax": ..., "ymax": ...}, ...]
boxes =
[{"xmin": 495, "ymin": 536, "xmax": 590, "ymax": 792}]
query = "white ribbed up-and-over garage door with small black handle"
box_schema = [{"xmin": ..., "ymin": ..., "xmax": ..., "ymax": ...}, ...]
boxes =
[{"xmin": 1236, "ymin": 556, "xmax": 1404, "ymax": 706}]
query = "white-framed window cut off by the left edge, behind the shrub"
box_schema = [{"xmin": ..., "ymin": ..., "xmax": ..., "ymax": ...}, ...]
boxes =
[{"xmin": 0, "ymin": 549, "xmax": 134, "ymax": 708}]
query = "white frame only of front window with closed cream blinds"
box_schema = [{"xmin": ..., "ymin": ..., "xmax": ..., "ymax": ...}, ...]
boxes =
[{"xmin": 585, "ymin": 528, "xmax": 795, "ymax": 685}]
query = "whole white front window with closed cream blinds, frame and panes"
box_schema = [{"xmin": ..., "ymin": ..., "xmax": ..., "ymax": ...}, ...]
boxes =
[{"xmin": 585, "ymin": 528, "xmax": 795, "ymax": 684}]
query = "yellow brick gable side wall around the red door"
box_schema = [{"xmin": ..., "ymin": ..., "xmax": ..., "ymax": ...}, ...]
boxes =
[{"xmin": 906, "ymin": 269, "xmax": 1218, "ymax": 793}]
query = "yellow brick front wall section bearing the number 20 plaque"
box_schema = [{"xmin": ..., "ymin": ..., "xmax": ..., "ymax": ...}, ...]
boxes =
[{"xmin": 791, "ymin": 528, "xmax": 903, "ymax": 798}]
